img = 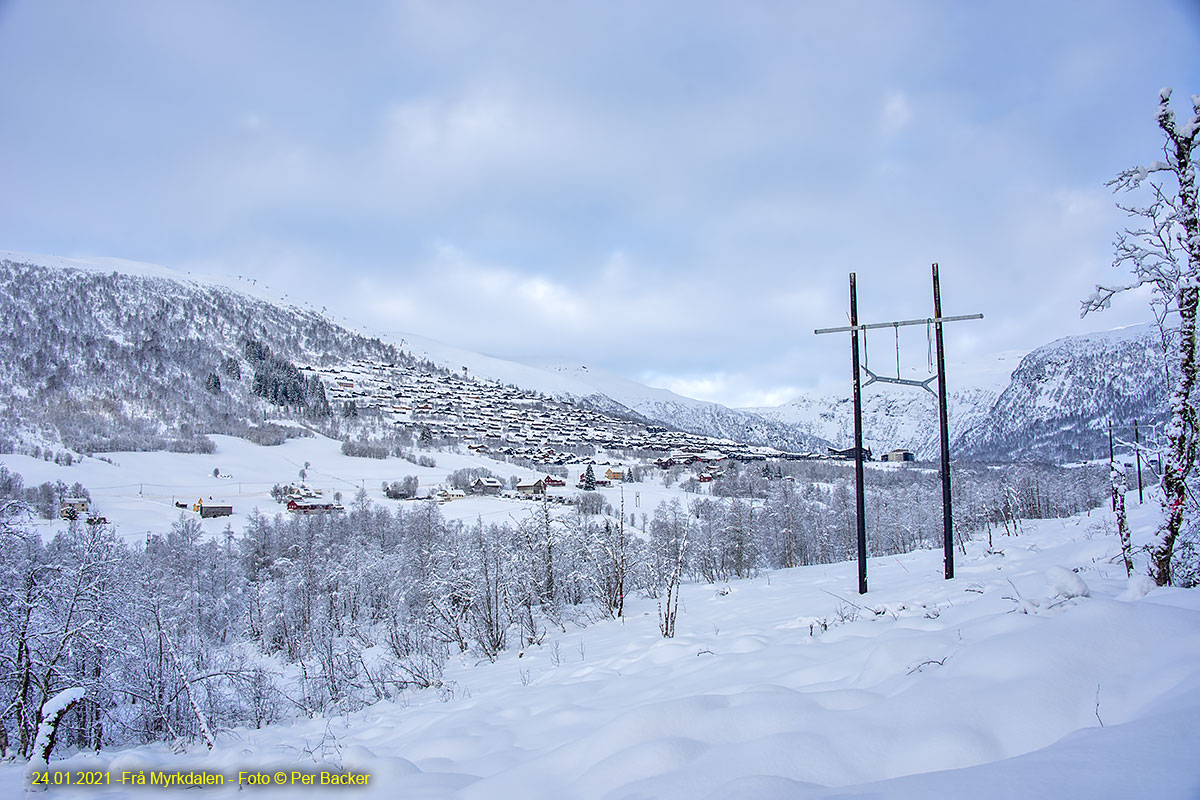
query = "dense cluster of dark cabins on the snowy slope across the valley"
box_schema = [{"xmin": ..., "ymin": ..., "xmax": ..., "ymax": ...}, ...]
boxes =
[{"xmin": 103, "ymin": 359, "xmax": 914, "ymax": 527}]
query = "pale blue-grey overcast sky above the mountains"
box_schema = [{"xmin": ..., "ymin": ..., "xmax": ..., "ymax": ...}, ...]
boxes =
[{"xmin": 0, "ymin": 0, "xmax": 1200, "ymax": 405}]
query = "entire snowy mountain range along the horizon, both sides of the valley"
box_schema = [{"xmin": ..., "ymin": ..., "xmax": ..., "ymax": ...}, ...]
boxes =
[{"xmin": 0, "ymin": 253, "xmax": 1166, "ymax": 461}]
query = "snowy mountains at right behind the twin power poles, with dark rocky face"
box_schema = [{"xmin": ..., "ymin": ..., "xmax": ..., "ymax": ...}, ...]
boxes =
[{"xmin": 750, "ymin": 325, "xmax": 1166, "ymax": 463}]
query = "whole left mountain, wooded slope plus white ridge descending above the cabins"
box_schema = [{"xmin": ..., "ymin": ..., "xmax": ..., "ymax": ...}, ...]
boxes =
[{"xmin": 0, "ymin": 253, "xmax": 827, "ymax": 460}]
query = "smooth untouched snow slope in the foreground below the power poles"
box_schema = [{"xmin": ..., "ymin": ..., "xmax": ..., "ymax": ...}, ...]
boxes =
[{"xmin": 0, "ymin": 491, "xmax": 1200, "ymax": 800}]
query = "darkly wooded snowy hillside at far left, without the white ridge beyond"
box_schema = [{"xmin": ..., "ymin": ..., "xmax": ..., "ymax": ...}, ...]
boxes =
[{"xmin": 0, "ymin": 254, "xmax": 409, "ymax": 453}]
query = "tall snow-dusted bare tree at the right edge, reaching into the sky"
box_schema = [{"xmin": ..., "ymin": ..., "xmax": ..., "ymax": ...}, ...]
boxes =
[{"xmin": 1082, "ymin": 89, "xmax": 1200, "ymax": 585}]
